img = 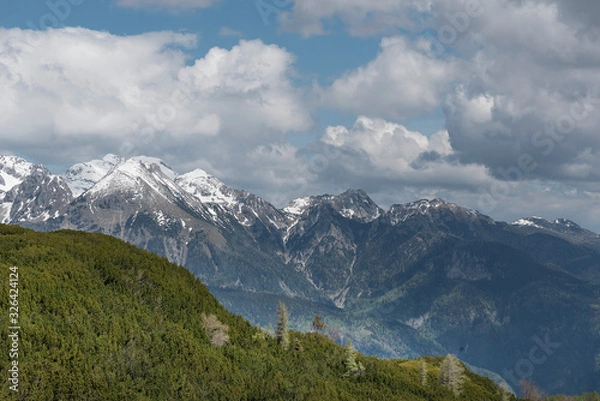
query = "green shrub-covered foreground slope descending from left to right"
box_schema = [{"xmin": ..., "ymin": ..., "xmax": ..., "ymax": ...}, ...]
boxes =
[{"xmin": 0, "ymin": 225, "xmax": 597, "ymax": 401}]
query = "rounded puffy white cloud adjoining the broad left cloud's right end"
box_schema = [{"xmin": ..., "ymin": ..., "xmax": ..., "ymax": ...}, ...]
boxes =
[{"xmin": 178, "ymin": 40, "xmax": 310, "ymax": 135}]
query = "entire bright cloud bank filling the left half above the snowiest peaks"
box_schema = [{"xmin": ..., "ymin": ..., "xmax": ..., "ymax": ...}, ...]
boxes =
[{"xmin": 0, "ymin": 28, "xmax": 311, "ymax": 174}]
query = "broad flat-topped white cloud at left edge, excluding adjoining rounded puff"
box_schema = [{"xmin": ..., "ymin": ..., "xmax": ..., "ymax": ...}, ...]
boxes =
[{"xmin": 0, "ymin": 28, "xmax": 195, "ymax": 141}]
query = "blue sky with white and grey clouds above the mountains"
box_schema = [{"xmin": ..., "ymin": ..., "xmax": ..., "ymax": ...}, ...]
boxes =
[{"xmin": 0, "ymin": 0, "xmax": 600, "ymax": 232}]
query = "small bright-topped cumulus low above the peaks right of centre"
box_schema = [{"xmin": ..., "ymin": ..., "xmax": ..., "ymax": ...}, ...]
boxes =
[{"xmin": 321, "ymin": 116, "xmax": 491, "ymax": 190}]
